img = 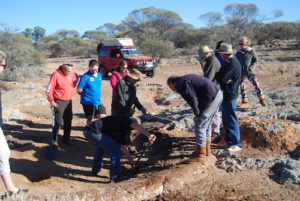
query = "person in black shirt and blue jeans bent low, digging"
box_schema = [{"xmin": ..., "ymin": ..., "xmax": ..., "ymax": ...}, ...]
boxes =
[{"xmin": 83, "ymin": 115, "xmax": 156, "ymax": 181}]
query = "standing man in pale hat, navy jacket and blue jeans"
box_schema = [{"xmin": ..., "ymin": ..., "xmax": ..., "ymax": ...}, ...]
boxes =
[{"xmin": 216, "ymin": 43, "xmax": 241, "ymax": 152}]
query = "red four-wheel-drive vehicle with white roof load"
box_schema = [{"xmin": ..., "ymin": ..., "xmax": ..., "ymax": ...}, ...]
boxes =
[{"xmin": 97, "ymin": 38, "xmax": 157, "ymax": 77}]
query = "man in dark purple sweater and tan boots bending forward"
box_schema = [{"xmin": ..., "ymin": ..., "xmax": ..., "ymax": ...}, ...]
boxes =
[{"xmin": 167, "ymin": 74, "xmax": 223, "ymax": 163}]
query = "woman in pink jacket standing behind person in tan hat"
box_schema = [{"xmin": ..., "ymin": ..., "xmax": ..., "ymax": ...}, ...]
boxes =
[{"xmin": 110, "ymin": 60, "xmax": 129, "ymax": 99}]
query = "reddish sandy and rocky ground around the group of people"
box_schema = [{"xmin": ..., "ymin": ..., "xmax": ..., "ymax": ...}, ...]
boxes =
[{"xmin": 0, "ymin": 46, "xmax": 300, "ymax": 201}]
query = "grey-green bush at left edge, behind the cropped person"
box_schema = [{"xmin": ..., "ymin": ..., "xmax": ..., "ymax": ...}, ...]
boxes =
[{"xmin": 0, "ymin": 32, "xmax": 44, "ymax": 81}]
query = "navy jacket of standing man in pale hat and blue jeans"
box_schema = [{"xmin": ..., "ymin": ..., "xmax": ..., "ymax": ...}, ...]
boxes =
[{"xmin": 216, "ymin": 56, "xmax": 241, "ymax": 100}]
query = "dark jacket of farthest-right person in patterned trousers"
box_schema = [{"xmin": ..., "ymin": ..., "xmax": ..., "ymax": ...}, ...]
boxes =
[{"xmin": 235, "ymin": 47, "xmax": 258, "ymax": 76}]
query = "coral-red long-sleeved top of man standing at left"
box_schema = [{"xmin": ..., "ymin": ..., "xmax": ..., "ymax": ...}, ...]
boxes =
[{"xmin": 46, "ymin": 68, "xmax": 78, "ymax": 102}]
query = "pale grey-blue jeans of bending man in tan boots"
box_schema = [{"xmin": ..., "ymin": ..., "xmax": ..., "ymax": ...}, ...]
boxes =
[{"xmin": 195, "ymin": 90, "xmax": 223, "ymax": 146}]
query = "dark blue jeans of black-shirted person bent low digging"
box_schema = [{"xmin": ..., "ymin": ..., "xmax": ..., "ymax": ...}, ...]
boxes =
[{"xmin": 83, "ymin": 129, "xmax": 121, "ymax": 178}]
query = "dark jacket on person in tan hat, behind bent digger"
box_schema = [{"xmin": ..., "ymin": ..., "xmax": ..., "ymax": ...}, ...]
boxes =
[{"xmin": 112, "ymin": 76, "xmax": 143, "ymax": 114}]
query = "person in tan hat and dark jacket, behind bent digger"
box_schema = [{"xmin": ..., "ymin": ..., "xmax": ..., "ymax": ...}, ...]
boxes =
[{"xmin": 112, "ymin": 69, "xmax": 147, "ymax": 116}]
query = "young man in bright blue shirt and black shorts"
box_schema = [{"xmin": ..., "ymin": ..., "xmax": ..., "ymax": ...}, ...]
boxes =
[{"xmin": 77, "ymin": 59, "xmax": 106, "ymax": 123}]
